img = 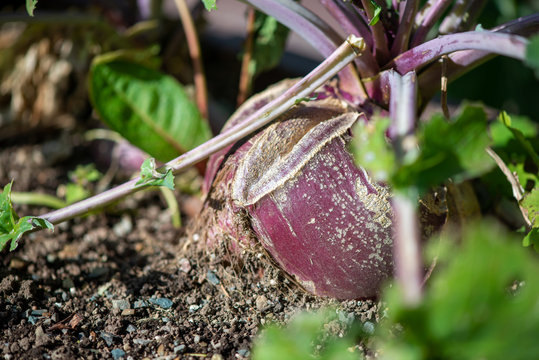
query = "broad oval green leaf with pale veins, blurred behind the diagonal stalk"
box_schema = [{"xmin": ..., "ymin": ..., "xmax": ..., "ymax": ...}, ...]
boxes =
[{"xmin": 89, "ymin": 56, "xmax": 211, "ymax": 162}]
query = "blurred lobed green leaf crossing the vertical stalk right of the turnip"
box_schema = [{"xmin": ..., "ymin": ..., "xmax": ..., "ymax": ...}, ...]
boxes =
[{"xmin": 351, "ymin": 105, "xmax": 494, "ymax": 193}]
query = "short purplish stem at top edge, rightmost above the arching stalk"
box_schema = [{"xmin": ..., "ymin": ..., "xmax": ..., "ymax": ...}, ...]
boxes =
[{"xmin": 438, "ymin": 0, "xmax": 487, "ymax": 34}]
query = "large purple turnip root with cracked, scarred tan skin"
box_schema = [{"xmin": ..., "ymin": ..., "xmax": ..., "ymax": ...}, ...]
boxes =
[{"xmin": 196, "ymin": 80, "xmax": 393, "ymax": 299}]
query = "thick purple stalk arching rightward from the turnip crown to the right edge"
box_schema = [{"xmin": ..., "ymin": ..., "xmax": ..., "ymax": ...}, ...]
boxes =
[{"xmin": 386, "ymin": 31, "xmax": 528, "ymax": 74}]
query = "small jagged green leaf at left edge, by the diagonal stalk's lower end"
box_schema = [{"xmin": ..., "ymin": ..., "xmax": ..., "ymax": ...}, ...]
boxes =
[{"xmin": 0, "ymin": 183, "xmax": 54, "ymax": 251}]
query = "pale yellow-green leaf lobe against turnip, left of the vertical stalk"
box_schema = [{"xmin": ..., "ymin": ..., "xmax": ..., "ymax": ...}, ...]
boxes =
[{"xmin": 350, "ymin": 116, "xmax": 396, "ymax": 181}]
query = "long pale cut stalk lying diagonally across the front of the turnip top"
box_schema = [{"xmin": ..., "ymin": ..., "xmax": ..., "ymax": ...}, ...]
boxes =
[{"xmin": 41, "ymin": 36, "xmax": 365, "ymax": 224}]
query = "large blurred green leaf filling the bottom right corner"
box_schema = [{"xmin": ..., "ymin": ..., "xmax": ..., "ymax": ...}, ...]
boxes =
[{"xmin": 377, "ymin": 222, "xmax": 539, "ymax": 360}]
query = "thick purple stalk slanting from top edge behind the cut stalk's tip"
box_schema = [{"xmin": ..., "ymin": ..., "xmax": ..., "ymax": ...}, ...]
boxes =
[{"xmin": 242, "ymin": 0, "xmax": 370, "ymax": 99}]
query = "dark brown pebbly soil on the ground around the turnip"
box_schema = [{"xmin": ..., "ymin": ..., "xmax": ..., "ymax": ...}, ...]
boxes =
[{"xmin": 0, "ymin": 130, "xmax": 377, "ymax": 359}]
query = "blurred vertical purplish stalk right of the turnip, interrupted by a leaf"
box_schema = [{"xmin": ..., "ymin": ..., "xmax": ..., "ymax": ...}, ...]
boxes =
[{"xmin": 389, "ymin": 71, "xmax": 422, "ymax": 306}]
